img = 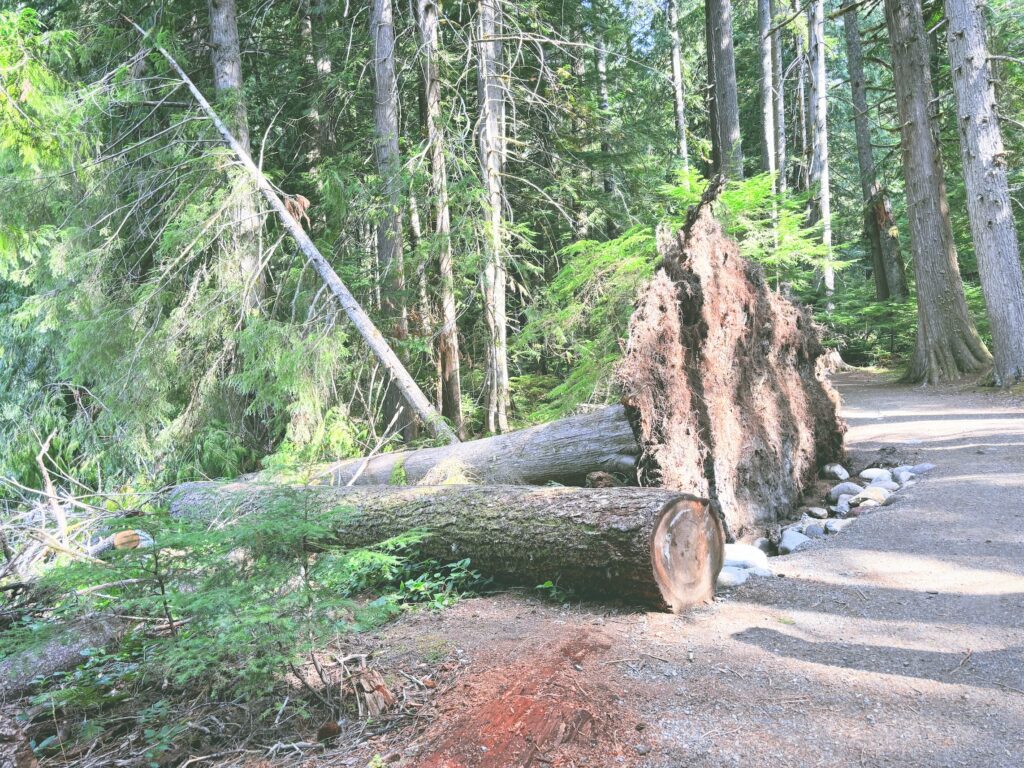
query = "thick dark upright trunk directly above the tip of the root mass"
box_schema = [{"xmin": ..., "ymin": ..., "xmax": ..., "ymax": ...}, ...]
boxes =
[{"xmin": 705, "ymin": 0, "xmax": 743, "ymax": 180}]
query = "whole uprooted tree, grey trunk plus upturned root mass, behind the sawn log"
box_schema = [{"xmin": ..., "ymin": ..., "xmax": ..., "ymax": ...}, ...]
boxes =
[{"xmin": 245, "ymin": 189, "xmax": 843, "ymax": 539}]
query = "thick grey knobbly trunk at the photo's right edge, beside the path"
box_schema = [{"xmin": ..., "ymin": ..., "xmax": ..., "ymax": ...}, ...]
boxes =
[{"xmin": 945, "ymin": 0, "xmax": 1024, "ymax": 386}]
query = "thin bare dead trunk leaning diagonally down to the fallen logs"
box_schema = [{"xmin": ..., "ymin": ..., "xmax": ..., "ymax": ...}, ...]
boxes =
[{"xmin": 122, "ymin": 15, "xmax": 459, "ymax": 443}]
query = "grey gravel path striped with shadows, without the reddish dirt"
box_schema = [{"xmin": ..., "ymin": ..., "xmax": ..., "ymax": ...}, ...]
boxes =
[{"xmin": 631, "ymin": 374, "xmax": 1024, "ymax": 768}]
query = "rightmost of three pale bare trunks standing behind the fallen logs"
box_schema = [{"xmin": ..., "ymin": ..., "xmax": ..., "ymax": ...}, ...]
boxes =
[{"xmin": 477, "ymin": 0, "xmax": 510, "ymax": 432}]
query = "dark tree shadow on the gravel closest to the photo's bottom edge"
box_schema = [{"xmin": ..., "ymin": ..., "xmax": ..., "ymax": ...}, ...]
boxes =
[{"xmin": 732, "ymin": 627, "xmax": 1024, "ymax": 695}]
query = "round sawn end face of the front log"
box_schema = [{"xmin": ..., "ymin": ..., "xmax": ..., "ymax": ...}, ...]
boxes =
[{"xmin": 650, "ymin": 496, "xmax": 725, "ymax": 613}]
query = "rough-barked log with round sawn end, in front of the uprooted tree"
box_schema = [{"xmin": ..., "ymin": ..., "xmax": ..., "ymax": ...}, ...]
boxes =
[{"xmin": 170, "ymin": 482, "xmax": 724, "ymax": 611}]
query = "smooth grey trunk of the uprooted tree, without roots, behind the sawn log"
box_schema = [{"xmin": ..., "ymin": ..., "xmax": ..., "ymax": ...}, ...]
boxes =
[{"xmin": 266, "ymin": 406, "xmax": 640, "ymax": 485}]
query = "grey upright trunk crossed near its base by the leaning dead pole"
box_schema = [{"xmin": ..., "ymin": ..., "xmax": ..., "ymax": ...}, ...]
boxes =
[{"xmin": 370, "ymin": 0, "xmax": 416, "ymax": 440}]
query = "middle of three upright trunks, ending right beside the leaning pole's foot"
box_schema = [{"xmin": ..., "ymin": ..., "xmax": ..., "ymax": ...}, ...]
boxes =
[{"xmin": 419, "ymin": 0, "xmax": 465, "ymax": 437}]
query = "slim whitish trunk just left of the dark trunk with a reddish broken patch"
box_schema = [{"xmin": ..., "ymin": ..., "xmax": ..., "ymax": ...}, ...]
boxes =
[{"xmin": 807, "ymin": 0, "xmax": 836, "ymax": 301}]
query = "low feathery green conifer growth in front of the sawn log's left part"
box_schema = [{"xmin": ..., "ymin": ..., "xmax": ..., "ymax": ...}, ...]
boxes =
[{"xmin": 0, "ymin": 489, "xmax": 483, "ymax": 765}]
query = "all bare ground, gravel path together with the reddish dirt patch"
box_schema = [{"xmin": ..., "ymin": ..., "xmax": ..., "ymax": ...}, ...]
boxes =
[{"xmin": 314, "ymin": 373, "xmax": 1024, "ymax": 768}]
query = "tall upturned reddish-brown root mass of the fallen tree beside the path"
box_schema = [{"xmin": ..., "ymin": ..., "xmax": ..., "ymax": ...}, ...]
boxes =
[{"xmin": 618, "ymin": 205, "xmax": 845, "ymax": 540}]
